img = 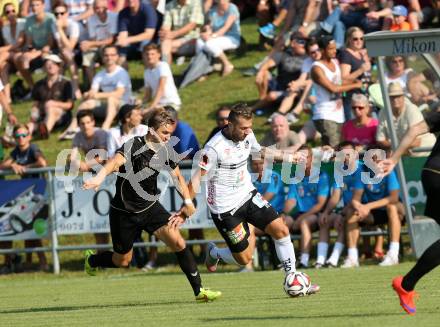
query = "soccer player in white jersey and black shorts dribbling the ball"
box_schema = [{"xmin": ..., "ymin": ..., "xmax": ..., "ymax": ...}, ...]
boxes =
[{"xmin": 184, "ymin": 104, "xmax": 319, "ymax": 294}]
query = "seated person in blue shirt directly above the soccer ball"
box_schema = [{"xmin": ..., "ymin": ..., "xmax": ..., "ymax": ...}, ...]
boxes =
[{"xmin": 283, "ymin": 145, "xmax": 330, "ymax": 268}]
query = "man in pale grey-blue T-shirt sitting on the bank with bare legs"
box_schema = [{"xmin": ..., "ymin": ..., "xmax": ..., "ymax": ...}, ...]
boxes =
[{"xmin": 60, "ymin": 45, "xmax": 131, "ymax": 139}]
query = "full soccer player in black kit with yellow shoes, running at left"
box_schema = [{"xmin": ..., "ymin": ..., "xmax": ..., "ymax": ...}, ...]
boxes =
[{"xmin": 83, "ymin": 108, "xmax": 221, "ymax": 302}]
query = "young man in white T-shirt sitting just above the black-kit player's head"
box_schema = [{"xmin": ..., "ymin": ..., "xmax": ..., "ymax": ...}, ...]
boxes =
[{"xmin": 143, "ymin": 44, "xmax": 182, "ymax": 110}]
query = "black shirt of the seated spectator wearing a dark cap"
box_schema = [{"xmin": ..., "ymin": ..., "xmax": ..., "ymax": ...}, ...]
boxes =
[{"xmin": 274, "ymin": 48, "xmax": 305, "ymax": 90}]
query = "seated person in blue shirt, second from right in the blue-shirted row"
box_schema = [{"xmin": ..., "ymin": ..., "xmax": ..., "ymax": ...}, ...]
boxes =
[{"xmin": 315, "ymin": 141, "xmax": 363, "ymax": 268}]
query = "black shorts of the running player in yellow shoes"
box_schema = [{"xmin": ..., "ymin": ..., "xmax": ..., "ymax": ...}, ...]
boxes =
[{"xmin": 109, "ymin": 201, "xmax": 171, "ymax": 254}]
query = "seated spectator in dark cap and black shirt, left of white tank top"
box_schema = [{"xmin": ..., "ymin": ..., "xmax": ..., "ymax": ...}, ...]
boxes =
[{"xmin": 254, "ymin": 32, "xmax": 306, "ymax": 113}]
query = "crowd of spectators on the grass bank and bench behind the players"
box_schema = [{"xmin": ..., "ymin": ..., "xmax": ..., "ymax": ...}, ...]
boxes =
[{"xmin": 0, "ymin": 0, "xmax": 440, "ymax": 270}]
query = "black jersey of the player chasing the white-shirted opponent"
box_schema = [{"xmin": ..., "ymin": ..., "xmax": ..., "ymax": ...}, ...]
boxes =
[{"xmin": 111, "ymin": 136, "xmax": 178, "ymax": 213}]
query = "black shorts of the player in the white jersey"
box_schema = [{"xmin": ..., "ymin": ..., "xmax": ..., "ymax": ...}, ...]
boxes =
[{"xmin": 211, "ymin": 190, "xmax": 278, "ymax": 253}]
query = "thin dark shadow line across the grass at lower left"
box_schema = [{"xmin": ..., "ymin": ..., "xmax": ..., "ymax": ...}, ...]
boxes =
[{"xmin": 0, "ymin": 301, "xmax": 188, "ymax": 314}]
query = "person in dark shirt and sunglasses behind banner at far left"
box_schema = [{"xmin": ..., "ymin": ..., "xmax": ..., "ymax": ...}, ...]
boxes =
[{"xmin": 0, "ymin": 125, "xmax": 49, "ymax": 271}]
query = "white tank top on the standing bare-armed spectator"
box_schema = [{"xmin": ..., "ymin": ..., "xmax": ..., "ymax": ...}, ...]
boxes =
[{"xmin": 312, "ymin": 59, "xmax": 345, "ymax": 123}]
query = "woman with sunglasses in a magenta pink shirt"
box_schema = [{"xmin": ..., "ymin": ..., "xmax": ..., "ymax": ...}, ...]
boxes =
[{"xmin": 342, "ymin": 93, "xmax": 379, "ymax": 150}]
